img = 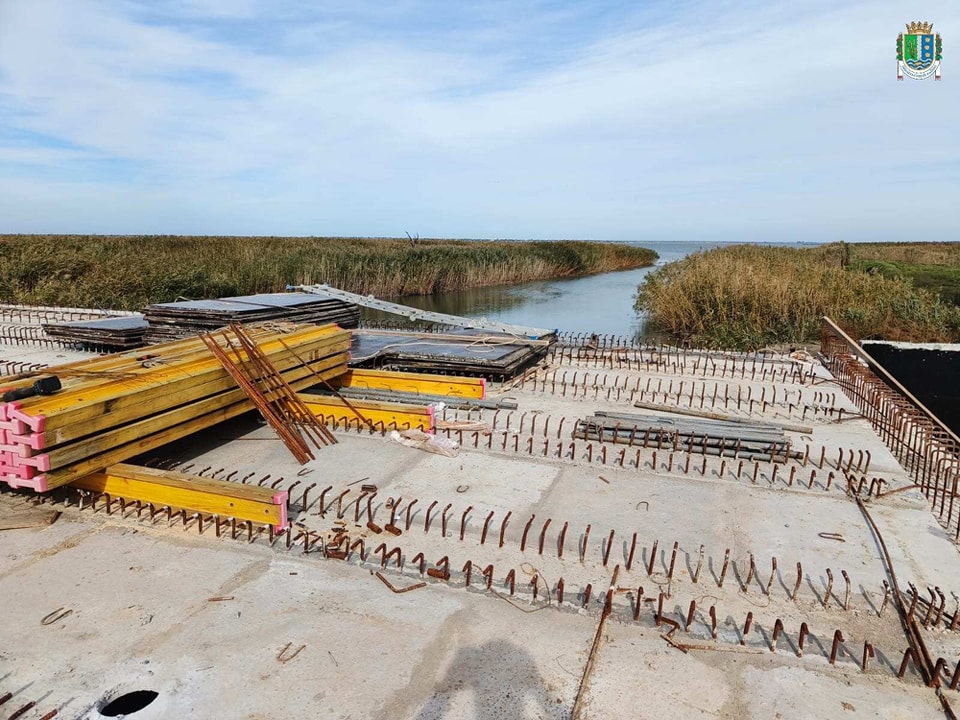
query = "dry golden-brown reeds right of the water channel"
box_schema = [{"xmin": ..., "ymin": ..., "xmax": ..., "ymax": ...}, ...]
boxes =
[{"xmin": 637, "ymin": 244, "xmax": 960, "ymax": 349}]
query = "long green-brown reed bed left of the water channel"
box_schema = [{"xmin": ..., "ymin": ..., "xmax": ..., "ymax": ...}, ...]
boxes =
[{"xmin": 0, "ymin": 235, "xmax": 657, "ymax": 310}]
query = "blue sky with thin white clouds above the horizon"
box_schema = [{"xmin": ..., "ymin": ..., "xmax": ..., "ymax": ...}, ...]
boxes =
[{"xmin": 0, "ymin": 0, "xmax": 960, "ymax": 242}]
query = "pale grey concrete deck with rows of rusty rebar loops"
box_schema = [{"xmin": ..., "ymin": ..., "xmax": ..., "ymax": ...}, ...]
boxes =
[{"xmin": 0, "ymin": 334, "xmax": 960, "ymax": 720}]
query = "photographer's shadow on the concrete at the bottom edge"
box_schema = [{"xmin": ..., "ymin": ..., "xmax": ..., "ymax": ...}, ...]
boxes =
[{"xmin": 416, "ymin": 640, "xmax": 559, "ymax": 720}]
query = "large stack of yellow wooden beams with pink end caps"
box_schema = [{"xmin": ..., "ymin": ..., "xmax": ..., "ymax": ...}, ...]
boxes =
[{"xmin": 0, "ymin": 323, "xmax": 350, "ymax": 492}]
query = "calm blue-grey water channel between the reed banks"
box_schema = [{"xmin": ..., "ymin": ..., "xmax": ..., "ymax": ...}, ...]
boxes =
[{"xmin": 365, "ymin": 242, "xmax": 732, "ymax": 337}]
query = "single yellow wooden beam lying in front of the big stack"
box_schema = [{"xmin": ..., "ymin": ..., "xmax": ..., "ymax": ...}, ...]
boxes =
[{"xmin": 70, "ymin": 464, "xmax": 287, "ymax": 529}]
